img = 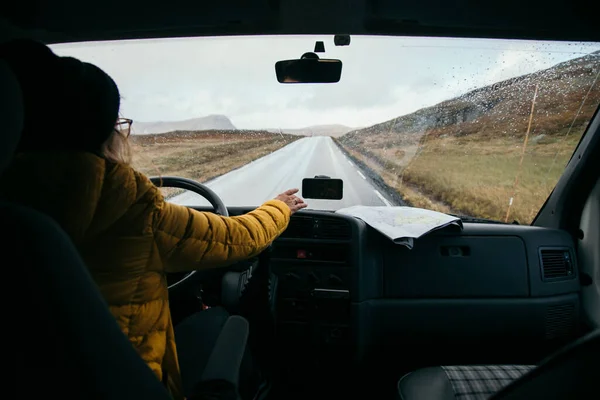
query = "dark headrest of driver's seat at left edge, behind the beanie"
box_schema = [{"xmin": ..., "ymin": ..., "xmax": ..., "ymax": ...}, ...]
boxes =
[{"xmin": 0, "ymin": 60, "xmax": 23, "ymax": 172}]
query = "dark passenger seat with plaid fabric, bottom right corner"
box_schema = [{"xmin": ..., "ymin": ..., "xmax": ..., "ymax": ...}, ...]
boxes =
[{"xmin": 398, "ymin": 330, "xmax": 600, "ymax": 400}]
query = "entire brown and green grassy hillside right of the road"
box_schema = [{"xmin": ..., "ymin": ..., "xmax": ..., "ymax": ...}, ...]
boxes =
[{"xmin": 337, "ymin": 54, "xmax": 600, "ymax": 224}]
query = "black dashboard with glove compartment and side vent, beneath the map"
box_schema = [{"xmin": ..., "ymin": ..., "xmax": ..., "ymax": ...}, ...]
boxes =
[{"xmin": 198, "ymin": 209, "xmax": 580, "ymax": 365}]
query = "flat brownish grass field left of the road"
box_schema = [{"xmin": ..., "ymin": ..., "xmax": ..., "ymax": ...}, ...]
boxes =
[{"xmin": 131, "ymin": 131, "xmax": 300, "ymax": 195}]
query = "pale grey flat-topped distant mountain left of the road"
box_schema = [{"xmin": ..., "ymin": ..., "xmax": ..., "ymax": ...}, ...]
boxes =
[{"xmin": 132, "ymin": 115, "xmax": 237, "ymax": 135}]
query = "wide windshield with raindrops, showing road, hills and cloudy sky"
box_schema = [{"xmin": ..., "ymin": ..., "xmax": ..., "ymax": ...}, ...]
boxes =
[{"xmin": 51, "ymin": 36, "xmax": 600, "ymax": 224}]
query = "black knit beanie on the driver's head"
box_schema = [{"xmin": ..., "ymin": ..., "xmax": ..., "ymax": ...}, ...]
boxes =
[{"xmin": 0, "ymin": 40, "xmax": 120, "ymax": 152}]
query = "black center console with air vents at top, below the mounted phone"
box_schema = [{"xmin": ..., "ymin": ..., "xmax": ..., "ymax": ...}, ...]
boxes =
[{"xmin": 271, "ymin": 216, "xmax": 353, "ymax": 370}]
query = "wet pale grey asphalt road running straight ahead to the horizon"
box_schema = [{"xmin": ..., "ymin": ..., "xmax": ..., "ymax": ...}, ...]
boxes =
[{"xmin": 169, "ymin": 136, "xmax": 393, "ymax": 210}]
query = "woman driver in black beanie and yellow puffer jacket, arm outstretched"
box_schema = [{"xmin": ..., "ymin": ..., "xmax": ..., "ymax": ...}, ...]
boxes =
[{"xmin": 0, "ymin": 41, "xmax": 306, "ymax": 398}]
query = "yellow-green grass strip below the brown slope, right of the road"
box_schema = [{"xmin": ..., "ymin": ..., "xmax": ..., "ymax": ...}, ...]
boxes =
[{"xmin": 340, "ymin": 134, "xmax": 580, "ymax": 223}]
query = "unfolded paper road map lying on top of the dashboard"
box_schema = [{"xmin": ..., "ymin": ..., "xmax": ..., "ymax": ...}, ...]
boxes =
[{"xmin": 336, "ymin": 206, "xmax": 462, "ymax": 249}]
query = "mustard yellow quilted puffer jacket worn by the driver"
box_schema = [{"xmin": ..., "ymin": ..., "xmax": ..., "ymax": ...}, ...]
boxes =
[{"xmin": 0, "ymin": 152, "xmax": 290, "ymax": 398}]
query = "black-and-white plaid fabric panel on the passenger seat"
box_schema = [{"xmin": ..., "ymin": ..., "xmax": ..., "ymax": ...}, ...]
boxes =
[{"xmin": 442, "ymin": 365, "xmax": 535, "ymax": 400}]
